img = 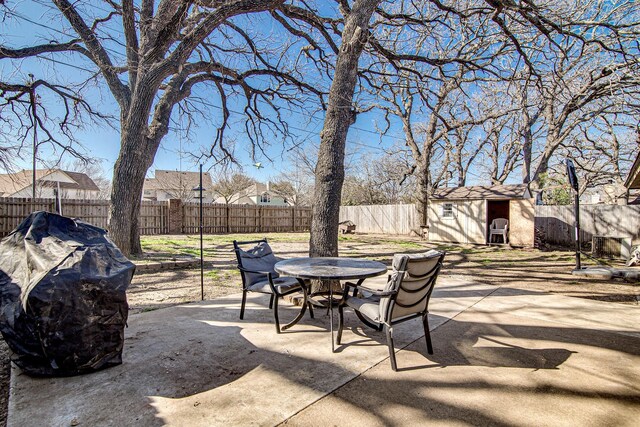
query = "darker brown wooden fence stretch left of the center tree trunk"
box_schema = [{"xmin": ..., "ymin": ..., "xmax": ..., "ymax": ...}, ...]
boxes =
[{"xmin": 0, "ymin": 198, "xmax": 311, "ymax": 237}]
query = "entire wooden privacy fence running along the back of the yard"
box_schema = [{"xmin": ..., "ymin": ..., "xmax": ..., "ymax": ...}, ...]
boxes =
[{"xmin": 0, "ymin": 198, "xmax": 640, "ymax": 245}]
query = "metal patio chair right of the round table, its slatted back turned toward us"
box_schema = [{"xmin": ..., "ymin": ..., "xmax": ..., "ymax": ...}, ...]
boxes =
[{"xmin": 337, "ymin": 251, "xmax": 445, "ymax": 371}]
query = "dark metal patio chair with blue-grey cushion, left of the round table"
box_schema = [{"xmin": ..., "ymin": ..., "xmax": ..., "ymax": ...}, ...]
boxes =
[{"xmin": 233, "ymin": 239, "xmax": 313, "ymax": 333}]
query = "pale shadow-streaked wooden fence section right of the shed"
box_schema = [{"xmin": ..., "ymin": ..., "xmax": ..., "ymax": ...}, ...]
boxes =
[{"xmin": 535, "ymin": 205, "xmax": 640, "ymax": 245}]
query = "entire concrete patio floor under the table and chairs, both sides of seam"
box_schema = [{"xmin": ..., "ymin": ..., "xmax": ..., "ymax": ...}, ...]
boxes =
[{"xmin": 8, "ymin": 277, "xmax": 640, "ymax": 426}]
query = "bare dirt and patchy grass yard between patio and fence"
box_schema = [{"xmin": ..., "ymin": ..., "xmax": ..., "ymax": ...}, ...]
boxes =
[{"xmin": 0, "ymin": 234, "xmax": 640, "ymax": 426}]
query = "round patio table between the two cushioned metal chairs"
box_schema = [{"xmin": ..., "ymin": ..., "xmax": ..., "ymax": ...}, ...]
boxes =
[{"xmin": 274, "ymin": 257, "xmax": 387, "ymax": 351}]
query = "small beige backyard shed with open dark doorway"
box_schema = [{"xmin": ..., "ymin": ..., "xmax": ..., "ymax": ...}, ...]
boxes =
[{"xmin": 429, "ymin": 184, "xmax": 535, "ymax": 246}]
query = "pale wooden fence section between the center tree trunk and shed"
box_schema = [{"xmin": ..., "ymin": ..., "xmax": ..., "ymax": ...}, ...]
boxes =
[{"xmin": 340, "ymin": 205, "xmax": 420, "ymax": 234}]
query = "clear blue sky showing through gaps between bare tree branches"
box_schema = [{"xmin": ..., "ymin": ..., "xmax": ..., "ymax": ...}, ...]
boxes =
[{"xmin": 0, "ymin": 0, "xmax": 519, "ymax": 189}]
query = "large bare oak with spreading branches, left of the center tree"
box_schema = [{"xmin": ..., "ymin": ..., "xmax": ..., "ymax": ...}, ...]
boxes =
[{"xmin": 0, "ymin": 0, "xmax": 321, "ymax": 254}]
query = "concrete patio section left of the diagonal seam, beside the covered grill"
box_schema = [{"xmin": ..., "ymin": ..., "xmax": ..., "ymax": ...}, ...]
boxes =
[{"xmin": 8, "ymin": 281, "xmax": 496, "ymax": 426}]
